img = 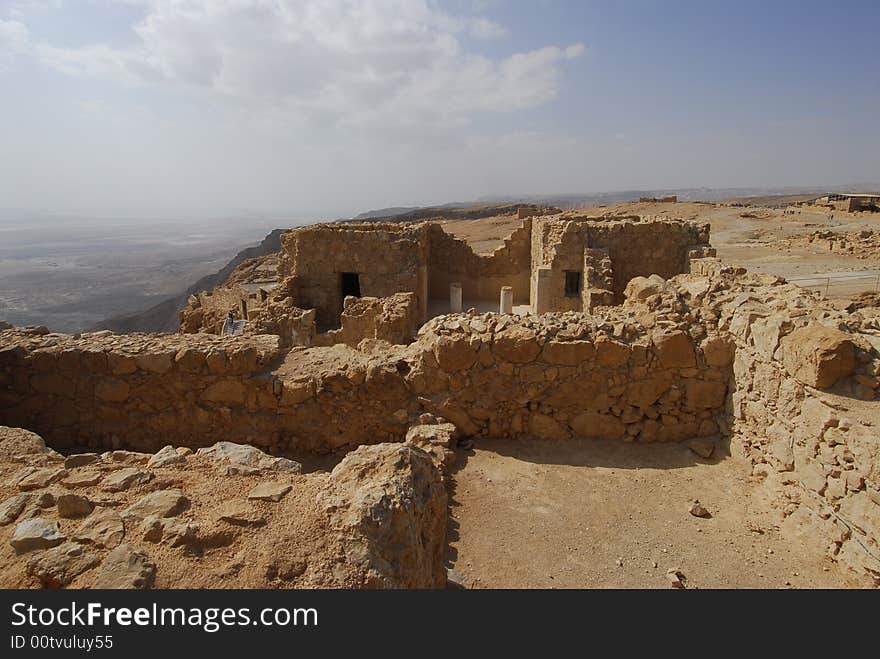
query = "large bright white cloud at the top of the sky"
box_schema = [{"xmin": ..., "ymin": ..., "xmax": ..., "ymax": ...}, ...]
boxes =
[{"xmin": 20, "ymin": 0, "xmax": 584, "ymax": 125}]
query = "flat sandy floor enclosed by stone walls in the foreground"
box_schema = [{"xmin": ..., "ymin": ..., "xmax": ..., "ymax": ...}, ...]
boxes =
[{"xmin": 448, "ymin": 441, "xmax": 860, "ymax": 588}]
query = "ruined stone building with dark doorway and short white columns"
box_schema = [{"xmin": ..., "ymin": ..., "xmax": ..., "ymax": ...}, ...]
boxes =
[{"xmin": 181, "ymin": 212, "xmax": 714, "ymax": 347}]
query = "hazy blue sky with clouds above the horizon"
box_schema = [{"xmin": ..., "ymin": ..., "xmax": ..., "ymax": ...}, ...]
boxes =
[{"xmin": 0, "ymin": 0, "xmax": 880, "ymax": 220}]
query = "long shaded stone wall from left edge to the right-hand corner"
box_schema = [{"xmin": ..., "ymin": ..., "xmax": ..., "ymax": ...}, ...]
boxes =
[{"xmin": 0, "ymin": 314, "xmax": 727, "ymax": 451}]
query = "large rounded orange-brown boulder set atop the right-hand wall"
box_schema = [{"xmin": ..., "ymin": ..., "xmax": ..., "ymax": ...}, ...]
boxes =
[{"xmin": 782, "ymin": 323, "xmax": 856, "ymax": 389}]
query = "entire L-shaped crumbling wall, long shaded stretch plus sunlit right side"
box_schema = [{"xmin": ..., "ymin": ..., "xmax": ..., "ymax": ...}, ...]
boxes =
[{"xmin": 0, "ymin": 259, "xmax": 880, "ymax": 577}]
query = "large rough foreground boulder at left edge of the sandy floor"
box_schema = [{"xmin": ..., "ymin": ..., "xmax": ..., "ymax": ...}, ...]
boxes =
[{"xmin": 318, "ymin": 444, "xmax": 446, "ymax": 588}]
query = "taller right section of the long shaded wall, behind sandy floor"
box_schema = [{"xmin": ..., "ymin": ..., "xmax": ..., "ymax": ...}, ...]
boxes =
[{"xmin": 406, "ymin": 314, "xmax": 731, "ymax": 442}]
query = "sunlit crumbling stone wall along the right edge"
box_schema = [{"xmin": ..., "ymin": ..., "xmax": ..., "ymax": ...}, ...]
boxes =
[{"xmin": 626, "ymin": 259, "xmax": 880, "ymax": 580}]
